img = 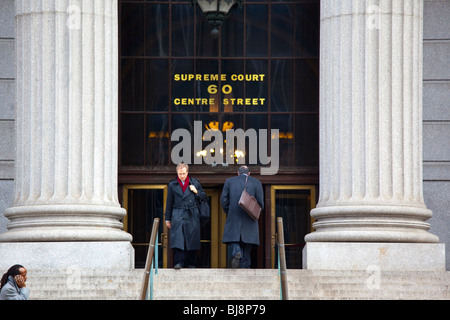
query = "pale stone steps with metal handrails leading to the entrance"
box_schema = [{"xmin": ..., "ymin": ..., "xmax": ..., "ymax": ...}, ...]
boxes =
[{"xmin": 27, "ymin": 269, "xmax": 450, "ymax": 300}]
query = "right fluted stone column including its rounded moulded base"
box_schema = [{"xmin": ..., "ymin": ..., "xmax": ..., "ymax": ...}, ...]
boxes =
[{"xmin": 306, "ymin": 0, "xmax": 445, "ymax": 268}]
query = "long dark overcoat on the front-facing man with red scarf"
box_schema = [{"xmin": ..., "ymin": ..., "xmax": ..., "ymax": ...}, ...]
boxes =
[{"xmin": 165, "ymin": 177, "xmax": 206, "ymax": 250}]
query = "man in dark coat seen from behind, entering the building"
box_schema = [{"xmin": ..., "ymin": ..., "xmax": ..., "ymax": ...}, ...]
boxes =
[{"xmin": 220, "ymin": 166, "xmax": 264, "ymax": 268}]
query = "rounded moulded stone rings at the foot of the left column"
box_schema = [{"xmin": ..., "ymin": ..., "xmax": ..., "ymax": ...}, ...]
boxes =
[{"xmin": 0, "ymin": 204, "xmax": 132, "ymax": 242}]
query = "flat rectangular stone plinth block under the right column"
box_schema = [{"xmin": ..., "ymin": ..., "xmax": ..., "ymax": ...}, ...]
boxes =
[{"xmin": 303, "ymin": 242, "xmax": 445, "ymax": 271}]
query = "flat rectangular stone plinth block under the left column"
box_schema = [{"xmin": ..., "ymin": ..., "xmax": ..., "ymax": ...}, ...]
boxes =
[{"xmin": 0, "ymin": 241, "xmax": 134, "ymax": 270}]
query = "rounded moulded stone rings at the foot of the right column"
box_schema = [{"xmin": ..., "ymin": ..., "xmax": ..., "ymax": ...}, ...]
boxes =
[{"xmin": 305, "ymin": 204, "xmax": 439, "ymax": 243}]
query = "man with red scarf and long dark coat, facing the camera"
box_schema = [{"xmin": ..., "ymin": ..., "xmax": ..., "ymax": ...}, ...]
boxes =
[{"xmin": 165, "ymin": 163, "xmax": 206, "ymax": 269}]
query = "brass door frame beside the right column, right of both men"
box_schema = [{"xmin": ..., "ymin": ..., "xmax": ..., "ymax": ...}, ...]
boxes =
[{"xmin": 270, "ymin": 185, "xmax": 316, "ymax": 268}]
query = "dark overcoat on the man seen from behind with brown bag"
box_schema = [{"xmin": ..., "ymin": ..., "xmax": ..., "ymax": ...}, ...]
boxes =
[{"xmin": 220, "ymin": 174, "xmax": 264, "ymax": 245}]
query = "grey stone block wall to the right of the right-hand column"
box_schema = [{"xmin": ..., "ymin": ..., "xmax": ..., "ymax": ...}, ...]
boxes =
[{"xmin": 423, "ymin": 0, "xmax": 450, "ymax": 270}]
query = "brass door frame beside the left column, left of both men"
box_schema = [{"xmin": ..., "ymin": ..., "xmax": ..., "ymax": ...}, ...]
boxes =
[{"xmin": 122, "ymin": 184, "xmax": 167, "ymax": 268}]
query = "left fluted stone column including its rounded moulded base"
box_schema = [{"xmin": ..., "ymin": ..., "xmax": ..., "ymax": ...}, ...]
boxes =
[{"xmin": 0, "ymin": 0, "xmax": 131, "ymax": 242}]
